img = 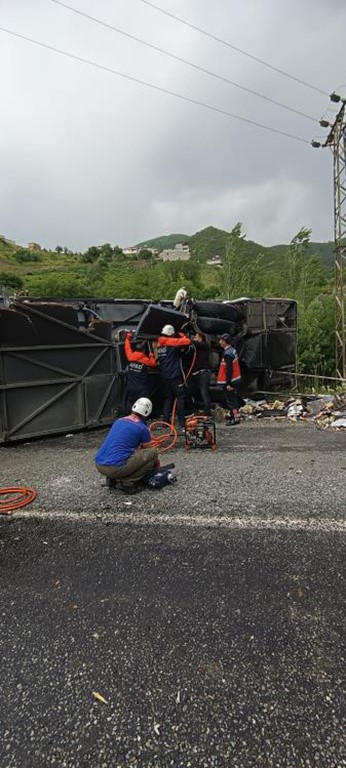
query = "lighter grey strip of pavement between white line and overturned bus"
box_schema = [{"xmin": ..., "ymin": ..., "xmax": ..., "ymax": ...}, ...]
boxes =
[{"xmin": 0, "ymin": 420, "xmax": 346, "ymax": 522}]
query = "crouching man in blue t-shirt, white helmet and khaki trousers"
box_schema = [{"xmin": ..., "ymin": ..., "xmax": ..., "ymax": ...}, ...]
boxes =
[{"xmin": 95, "ymin": 397, "xmax": 158, "ymax": 493}]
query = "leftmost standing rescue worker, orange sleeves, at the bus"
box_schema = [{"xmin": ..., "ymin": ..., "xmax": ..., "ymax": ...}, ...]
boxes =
[{"xmin": 124, "ymin": 331, "xmax": 157, "ymax": 410}]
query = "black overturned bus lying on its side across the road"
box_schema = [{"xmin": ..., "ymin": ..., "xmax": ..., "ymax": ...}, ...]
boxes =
[{"xmin": 0, "ymin": 297, "xmax": 297, "ymax": 444}]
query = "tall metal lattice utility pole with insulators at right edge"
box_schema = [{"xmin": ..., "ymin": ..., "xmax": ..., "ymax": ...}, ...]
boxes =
[{"xmin": 311, "ymin": 93, "xmax": 346, "ymax": 379}]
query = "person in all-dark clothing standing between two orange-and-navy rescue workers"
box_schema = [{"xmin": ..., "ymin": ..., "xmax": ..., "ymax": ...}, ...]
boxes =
[{"xmin": 186, "ymin": 333, "xmax": 211, "ymax": 416}]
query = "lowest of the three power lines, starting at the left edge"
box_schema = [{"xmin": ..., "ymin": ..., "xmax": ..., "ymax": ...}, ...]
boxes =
[{"xmin": 0, "ymin": 27, "xmax": 310, "ymax": 146}]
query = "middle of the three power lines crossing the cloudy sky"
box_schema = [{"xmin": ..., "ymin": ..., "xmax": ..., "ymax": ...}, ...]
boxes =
[{"xmin": 51, "ymin": 0, "xmax": 317, "ymax": 123}]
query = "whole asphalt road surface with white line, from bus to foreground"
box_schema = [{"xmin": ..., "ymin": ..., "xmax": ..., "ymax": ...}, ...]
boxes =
[{"xmin": 0, "ymin": 421, "xmax": 346, "ymax": 768}]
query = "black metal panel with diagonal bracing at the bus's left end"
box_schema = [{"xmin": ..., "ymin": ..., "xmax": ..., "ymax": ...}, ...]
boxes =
[{"xmin": 0, "ymin": 336, "xmax": 119, "ymax": 443}]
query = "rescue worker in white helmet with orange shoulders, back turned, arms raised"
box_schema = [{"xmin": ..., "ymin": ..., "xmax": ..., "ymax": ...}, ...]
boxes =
[{"xmin": 157, "ymin": 325, "xmax": 191, "ymax": 430}]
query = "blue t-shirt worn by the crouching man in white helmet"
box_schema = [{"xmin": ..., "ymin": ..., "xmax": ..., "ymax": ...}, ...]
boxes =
[{"xmin": 95, "ymin": 417, "xmax": 151, "ymax": 467}]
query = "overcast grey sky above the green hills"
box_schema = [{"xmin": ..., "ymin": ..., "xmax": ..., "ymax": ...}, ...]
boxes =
[{"xmin": 0, "ymin": 0, "xmax": 346, "ymax": 250}]
